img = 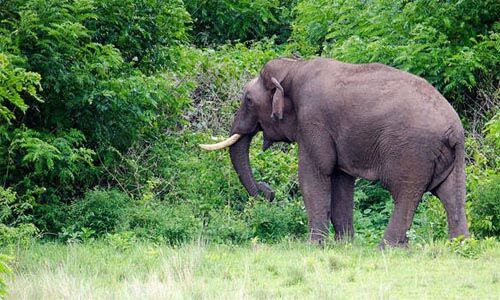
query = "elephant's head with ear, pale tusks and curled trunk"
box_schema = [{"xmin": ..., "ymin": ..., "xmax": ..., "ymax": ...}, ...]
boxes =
[{"xmin": 200, "ymin": 59, "xmax": 299, "ymax": 201}]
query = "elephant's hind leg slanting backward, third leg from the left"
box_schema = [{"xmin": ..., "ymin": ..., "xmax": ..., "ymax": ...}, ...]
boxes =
[{"xmin": 380, "ymin": 187, "xmax": 424, "ymax": 248}]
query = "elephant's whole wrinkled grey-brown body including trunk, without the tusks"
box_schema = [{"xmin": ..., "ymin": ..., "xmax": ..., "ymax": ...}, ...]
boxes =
[{"xmin": 230, "ymin": 59, "xmax": 469, "ymax": 247}]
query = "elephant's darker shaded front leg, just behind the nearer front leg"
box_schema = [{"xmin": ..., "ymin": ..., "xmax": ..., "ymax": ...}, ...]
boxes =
[{"xmin": 331, "ymin": 170, "xmax": 355, "ymax": 240}]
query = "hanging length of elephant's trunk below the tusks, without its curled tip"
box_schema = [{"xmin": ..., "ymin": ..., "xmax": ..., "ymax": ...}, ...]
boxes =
[{"xmin": 229, "ymin": 134, "xmax": 259, "ymax": 196}]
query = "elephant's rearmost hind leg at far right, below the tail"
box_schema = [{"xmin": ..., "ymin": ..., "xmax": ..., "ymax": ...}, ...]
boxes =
[{"xmin": 432, "ymin": 168, "xmax": 469, "ymax": 239}]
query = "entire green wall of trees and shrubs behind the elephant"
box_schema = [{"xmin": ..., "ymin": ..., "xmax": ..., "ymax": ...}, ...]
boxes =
[{"xmin": 0, "ymin": 0, "xmax": 500, "ymax": 298}]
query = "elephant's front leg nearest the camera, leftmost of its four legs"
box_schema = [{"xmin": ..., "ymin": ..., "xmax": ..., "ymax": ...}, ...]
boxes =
[{"xmin": 299, "ymin": 152, "xmax": 331, "ymax": 244}]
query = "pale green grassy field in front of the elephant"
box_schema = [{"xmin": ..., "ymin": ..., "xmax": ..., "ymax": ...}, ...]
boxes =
[{"xmin": 2, "ymin": 241, "xmax": 500, "ymax": 299}]
